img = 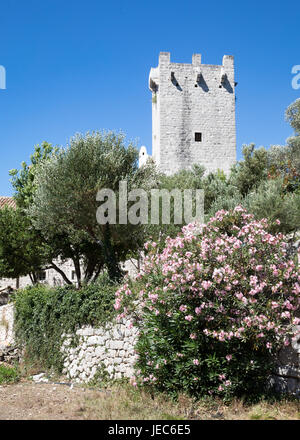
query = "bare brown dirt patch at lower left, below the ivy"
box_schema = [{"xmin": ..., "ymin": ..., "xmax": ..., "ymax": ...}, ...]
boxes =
[{"xmin": 0, "ymin": 381, "xmax": 105, "ymax": 420}]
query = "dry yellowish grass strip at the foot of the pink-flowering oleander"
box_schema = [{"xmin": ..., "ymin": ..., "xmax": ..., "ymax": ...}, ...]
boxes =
[{"xmin": 82, "ymin": 385, "xmax": 300, "ymax": 420}]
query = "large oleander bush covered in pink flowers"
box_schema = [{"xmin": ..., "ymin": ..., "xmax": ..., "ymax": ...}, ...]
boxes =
[{"xmin": 114, "ymin": 206, "xmax": 300, "ymax": 399}]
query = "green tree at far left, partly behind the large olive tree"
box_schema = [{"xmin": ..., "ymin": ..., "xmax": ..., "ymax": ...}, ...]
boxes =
[{"xmin": 0, "ymin": 142, "xmax": 59, "ymax": 282}]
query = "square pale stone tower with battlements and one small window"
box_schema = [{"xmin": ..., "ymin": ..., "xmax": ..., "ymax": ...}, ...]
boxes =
[{"xmin": 149, "ymin": 52, "xmax": 236, "ymax": 174}]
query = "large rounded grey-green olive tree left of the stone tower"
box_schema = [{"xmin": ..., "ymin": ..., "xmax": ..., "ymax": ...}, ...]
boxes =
[{"xmin": 29, "ymin": 132, "xmax": 157, "ymax": 281}]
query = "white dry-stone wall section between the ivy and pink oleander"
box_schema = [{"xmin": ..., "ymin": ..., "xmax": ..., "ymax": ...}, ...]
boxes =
[{"xmin": 61, "ymin": 321, "xmax": 138, "ymax": 382}]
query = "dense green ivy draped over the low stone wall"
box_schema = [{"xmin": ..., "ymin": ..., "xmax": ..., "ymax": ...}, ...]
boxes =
[{"xmin": 15, "ymin": 274, "xmax": 117, "ymax": 372}]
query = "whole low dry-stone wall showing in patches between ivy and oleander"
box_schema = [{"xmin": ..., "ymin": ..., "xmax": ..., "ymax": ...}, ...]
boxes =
[{"xmin": 0, "ymin": 304, "xmax": 300, "ymax": 396}]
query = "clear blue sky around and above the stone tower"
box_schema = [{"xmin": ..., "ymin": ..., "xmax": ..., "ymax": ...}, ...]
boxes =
[{"xmin": 0, "ymin": 0, "xmax": 300, "ymax": 195}]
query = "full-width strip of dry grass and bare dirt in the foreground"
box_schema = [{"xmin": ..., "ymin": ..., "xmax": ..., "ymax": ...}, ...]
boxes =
[{"xmin": 0, "ymin": 379, "xmax": 300, "ymax": 420}]
